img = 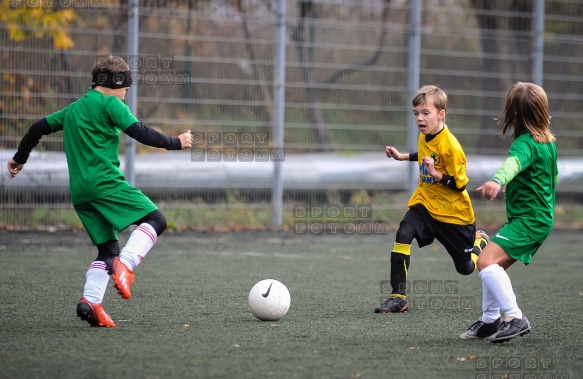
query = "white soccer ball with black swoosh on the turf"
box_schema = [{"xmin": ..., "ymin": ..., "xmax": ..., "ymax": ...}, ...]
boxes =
[{"xmin": 247, "ymin": 279, "xmax": 291, "ymax": 321}]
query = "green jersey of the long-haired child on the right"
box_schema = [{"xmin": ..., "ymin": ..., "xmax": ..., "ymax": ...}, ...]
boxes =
[{"xmin": 495, "ymin": 133, "xmax": 559, "ymax": 244}]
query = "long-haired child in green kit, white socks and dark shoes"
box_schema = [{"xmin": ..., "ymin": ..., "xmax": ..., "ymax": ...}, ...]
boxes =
[{"xmin": 460, "ymin": 82, "xmax": 558, "ymax": 342}]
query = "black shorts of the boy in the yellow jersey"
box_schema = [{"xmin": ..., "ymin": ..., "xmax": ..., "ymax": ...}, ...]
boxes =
[{"xmin": 401, "ymin": 204, "xmax": 476, "ymax": 262}]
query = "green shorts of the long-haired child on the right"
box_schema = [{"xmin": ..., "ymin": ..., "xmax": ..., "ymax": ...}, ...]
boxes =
[{"xmin": 490, "ymin": 221, "xmax": 541, "ymax": 264}]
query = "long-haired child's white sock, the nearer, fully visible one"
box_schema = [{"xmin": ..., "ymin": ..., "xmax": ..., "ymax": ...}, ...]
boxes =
[{"xmin": 480, "ymin": 264, "xmax": 522, "ymax": 319}]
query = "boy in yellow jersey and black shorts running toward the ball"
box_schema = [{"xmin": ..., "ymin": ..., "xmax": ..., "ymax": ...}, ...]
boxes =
[{"xmin": 375, "ymin": 86, "xmax": 488, "ymax": 313}]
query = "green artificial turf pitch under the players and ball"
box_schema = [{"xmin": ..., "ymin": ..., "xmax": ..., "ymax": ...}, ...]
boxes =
[{"xmin": 0, "ymin": 232, "xmax": 583, "ymax": 379}]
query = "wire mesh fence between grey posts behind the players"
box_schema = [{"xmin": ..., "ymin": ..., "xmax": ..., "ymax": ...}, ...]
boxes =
[{"xmin": 0, "ymin": 0, "xmax": 583, "ymax": 232}]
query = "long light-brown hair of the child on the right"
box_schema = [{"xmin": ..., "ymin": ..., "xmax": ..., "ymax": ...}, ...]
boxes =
[{"xmin": 496, "ymin": 82, "xmax": 555, "ymax": 143}]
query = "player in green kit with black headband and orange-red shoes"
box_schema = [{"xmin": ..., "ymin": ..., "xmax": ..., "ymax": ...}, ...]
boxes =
[{"xmin": 8, "ymin": 56, "xmax": 192, "ymax": 327}]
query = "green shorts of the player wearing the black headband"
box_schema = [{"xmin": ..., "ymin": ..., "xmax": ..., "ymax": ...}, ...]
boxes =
[{"xmin": 74, "ymin": 187, "xmax": 158, "ymax": 245}]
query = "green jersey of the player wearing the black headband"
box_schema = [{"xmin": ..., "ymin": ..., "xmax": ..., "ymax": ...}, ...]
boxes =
[{"xmin": 47, "ymin": 89, "xmax": 138, "ymax": 205}]
